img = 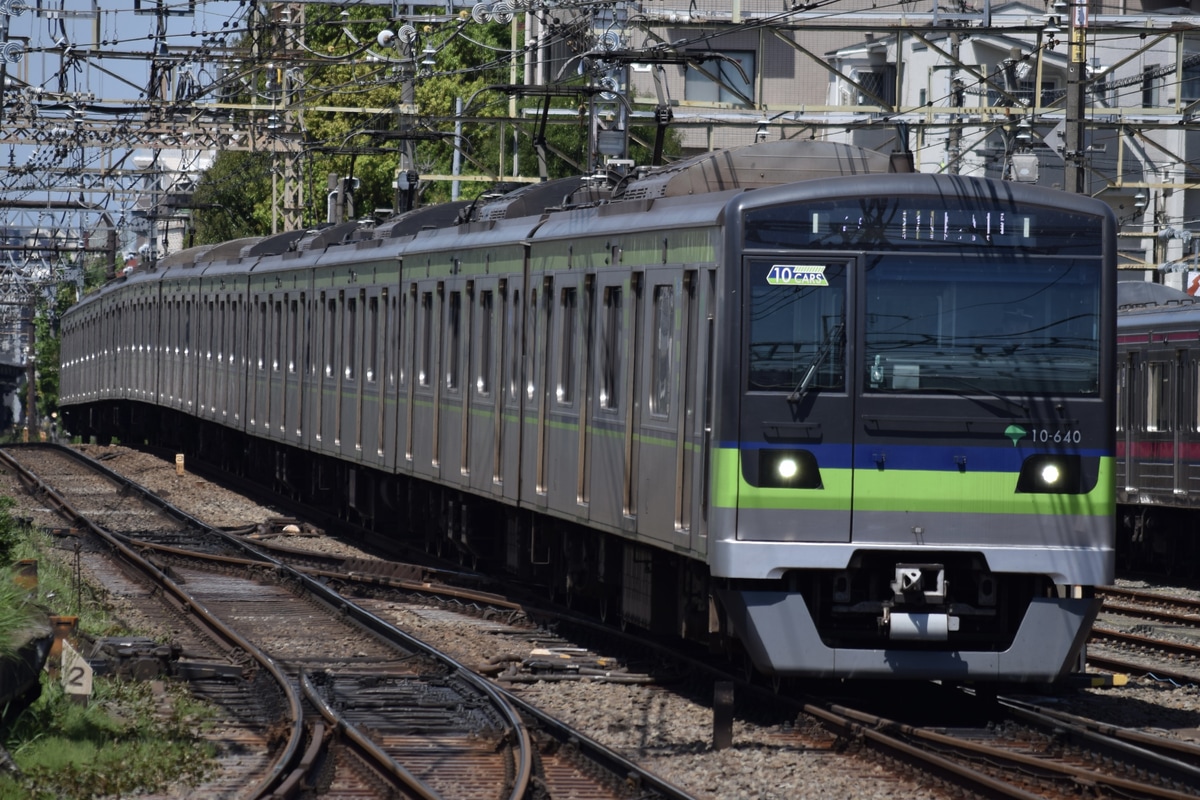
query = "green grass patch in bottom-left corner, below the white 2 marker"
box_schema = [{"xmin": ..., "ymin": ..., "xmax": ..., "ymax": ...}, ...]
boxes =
[{"xmin": 0, "ymin": 678, "xmax": 215, "ymax": 800}]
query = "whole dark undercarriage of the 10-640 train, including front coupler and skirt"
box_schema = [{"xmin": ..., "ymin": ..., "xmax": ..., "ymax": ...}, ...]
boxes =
[{"xmin": 66, "ymin": 403, "xmax": 1093, "ymax": 680}]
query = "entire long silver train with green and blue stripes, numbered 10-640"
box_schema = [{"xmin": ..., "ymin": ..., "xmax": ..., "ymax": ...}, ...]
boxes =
[{"xmin": 60, "ymin": 140, "xmax": 1116, "ymax": 682}]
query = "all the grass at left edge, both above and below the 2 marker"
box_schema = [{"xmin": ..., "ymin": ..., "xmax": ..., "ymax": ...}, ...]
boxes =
[{"xmin": 0, "ymin": 510, "xmax": 215, "ymax": 800}]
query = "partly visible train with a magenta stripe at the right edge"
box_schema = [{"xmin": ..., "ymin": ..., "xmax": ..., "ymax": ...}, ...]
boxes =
[{"xmin": 1116, "ymin": 281, "xmax": 1200, "ymax": 577}]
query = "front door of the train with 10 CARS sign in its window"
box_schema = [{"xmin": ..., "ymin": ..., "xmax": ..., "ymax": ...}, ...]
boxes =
[{"xmin": 736, "ymin": 253, "xmax": 857, "ymax": 542}]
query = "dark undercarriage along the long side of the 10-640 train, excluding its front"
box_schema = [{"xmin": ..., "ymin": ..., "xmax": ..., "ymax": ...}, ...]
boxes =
[{"xmin": 66, "ymin": 403, "xmax": 737, "ymax": 649}]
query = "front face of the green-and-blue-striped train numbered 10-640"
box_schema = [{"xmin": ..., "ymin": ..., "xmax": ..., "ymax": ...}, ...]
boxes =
[{"xmin": 709, "ymin": 175, "xmax": 1116, "ymax": 682}]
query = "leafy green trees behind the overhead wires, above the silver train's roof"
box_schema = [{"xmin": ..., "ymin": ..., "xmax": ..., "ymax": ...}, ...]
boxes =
[{"xmin": 188, "ymin": 5, "xmax": 679, "ymax": 227}]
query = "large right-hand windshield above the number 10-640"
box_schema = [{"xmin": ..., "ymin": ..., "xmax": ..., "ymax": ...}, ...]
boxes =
[{"xmin": 862, "ymin": 251, "xmax": 1102, "ymax": 396}]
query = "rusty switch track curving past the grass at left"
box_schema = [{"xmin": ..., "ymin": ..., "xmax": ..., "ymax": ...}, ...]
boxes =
[{"xmin": 4, "ymin": 447, "xmax": 686, "ymax": 799}]
